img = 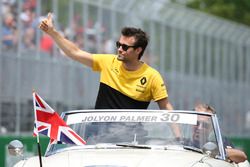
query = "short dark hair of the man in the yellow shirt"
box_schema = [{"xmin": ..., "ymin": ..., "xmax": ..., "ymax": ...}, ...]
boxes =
[{"xmin": 121, "ymin": 27, "xmax": 149, "ymax": 60}]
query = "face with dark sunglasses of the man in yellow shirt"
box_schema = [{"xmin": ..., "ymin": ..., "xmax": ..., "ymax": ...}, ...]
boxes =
[{"xmin": 117, "ymin": 36, "xmax": 139, "ymax": 62}]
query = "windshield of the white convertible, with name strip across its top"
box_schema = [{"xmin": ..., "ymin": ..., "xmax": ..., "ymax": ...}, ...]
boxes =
[{"xmin": 47, "ymin": 110, "xmax": 219, "ymax": 157}]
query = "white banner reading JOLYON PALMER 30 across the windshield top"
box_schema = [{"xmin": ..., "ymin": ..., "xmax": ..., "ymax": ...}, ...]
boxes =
[{"xmin": 67, "ymin": 112, "xmax": 197, "ymax": 125}]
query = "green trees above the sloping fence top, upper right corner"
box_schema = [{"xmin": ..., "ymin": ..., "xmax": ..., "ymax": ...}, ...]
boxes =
[{"xmin": 186, "ymin": 0, "xmax": 250, "ymax": 26}]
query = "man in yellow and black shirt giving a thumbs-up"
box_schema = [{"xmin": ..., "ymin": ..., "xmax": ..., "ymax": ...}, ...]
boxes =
[{"xmin": 39, "ymin": 13, "xmax": 173, "ymax": 110}]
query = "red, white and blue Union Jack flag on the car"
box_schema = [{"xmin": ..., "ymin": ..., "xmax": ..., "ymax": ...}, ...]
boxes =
[{"xmin": 33, "ymin": 92, "xmax": 86, "ymax": 145}]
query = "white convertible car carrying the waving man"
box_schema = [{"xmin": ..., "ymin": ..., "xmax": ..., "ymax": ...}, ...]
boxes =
[{"xmin": 9, "ymin": 110, "xmax": 249, "ymax": 167}]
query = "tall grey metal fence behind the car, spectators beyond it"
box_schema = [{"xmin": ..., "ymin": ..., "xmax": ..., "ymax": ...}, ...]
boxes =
[{"xmin": 0, "ymin": 0, "xmax": 250, "ymax": 136}]
